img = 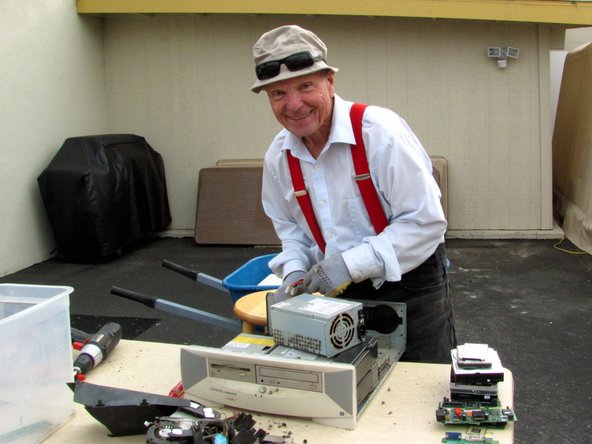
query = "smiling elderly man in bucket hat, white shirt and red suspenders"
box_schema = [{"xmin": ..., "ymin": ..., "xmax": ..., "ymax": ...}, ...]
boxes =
[{"xmin": 251, "ymin": 26, "xmax": 456, "ymax": 362}]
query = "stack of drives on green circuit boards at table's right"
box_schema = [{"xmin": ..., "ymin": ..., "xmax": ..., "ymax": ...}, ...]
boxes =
[{"xmin": 436, "ymin": 343, "xmax": 516, "ymax": 427}]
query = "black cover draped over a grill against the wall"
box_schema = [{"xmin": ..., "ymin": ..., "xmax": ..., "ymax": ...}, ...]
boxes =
[{"xmin": 37, "ymin": 134, "xmax": 171, "ymax": 261}]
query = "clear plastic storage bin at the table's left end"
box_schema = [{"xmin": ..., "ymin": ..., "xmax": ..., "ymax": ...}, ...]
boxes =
[{"xmin": 0, "ymin": 284, "xmax": 74, "ymax": 444}]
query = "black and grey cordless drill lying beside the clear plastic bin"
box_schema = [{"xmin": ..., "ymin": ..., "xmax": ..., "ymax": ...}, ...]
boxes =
[{"xmin": 72, "ymin": 322, "xmax": 121, "ymax": 380}]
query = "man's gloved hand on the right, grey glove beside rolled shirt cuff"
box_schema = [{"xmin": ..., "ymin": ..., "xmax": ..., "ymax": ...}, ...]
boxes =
[{"xmin": 303, "ymin": 254, "xmax": 352, "ymax": 297}]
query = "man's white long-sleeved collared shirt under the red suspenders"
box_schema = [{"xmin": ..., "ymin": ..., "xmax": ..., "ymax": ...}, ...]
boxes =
[{"xmin": 262, "ymin": 96, "xmax": 446, "ymax": 287}]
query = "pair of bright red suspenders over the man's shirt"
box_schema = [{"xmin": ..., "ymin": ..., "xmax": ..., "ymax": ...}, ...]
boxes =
[{"xmin": 286, "ymin": 103, "xmax": 388, "ymax": 253}]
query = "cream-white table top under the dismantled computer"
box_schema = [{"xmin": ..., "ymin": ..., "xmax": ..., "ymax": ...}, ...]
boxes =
[{"xmin": 45, "ymin": 340, "xmax": 514, "ymax": 444}]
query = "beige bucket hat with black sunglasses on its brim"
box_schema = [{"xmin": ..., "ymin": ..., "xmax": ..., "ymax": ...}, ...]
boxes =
[{"xmin": 251, "ymin": 25, "xmax": 338, "ymax": 93}]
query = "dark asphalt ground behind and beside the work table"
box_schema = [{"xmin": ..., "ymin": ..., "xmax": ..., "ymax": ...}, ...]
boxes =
[{"xmin": 0, "ymin": 238, "xmax": 592, "ymax": 443}]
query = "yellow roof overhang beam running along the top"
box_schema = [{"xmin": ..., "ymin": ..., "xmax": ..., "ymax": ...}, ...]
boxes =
[{"xmin": 76, "ymin": 0, "xmax": 592, "ymax": 26}]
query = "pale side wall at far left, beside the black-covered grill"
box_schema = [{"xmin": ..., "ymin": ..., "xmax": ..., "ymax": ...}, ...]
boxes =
[{"xmin": 0, "ymin": 0, "xmax": 107, "ymax": 276}]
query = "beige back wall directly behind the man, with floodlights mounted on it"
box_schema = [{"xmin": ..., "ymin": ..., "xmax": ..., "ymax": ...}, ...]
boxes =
[{"xmin": 104, "ymin": 16, "xmax": 552, "ymax": 237}]
